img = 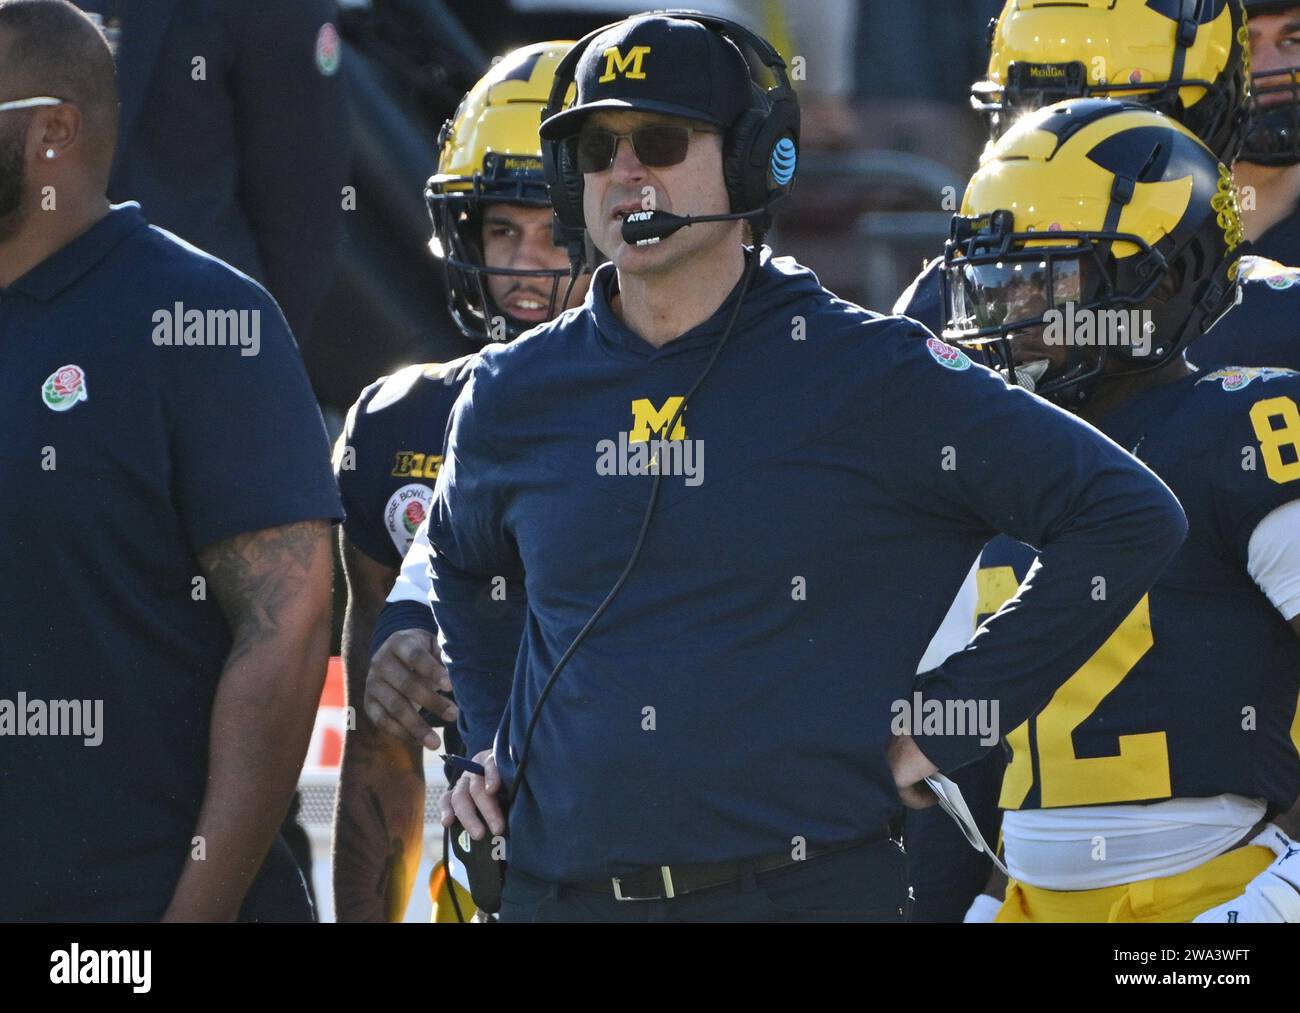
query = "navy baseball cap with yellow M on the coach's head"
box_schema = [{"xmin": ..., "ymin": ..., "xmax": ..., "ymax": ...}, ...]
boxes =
[{"xmin": 541, "ymin": 14, "xmax": 754, "ymax": 140}]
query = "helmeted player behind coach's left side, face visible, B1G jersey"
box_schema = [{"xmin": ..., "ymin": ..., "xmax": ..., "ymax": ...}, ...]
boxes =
[{"xmin": 334, "ymin": 42, "xmax": 588, "ymax": 922}]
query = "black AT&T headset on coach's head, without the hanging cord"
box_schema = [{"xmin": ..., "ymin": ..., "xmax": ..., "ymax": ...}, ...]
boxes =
[{"xmin": 542, "ymin": 10, "xmax": 800, "ymax": 269}]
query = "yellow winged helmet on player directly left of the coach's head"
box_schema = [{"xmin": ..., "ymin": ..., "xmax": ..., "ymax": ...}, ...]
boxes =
[{"xmin": 424, "ymin": 42, "xmax": 573, "ymax": 339}]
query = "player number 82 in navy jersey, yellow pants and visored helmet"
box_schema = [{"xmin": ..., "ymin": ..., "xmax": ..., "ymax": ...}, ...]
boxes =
[{"xmin": 943, "ymin": 100, "xmax": 1300, "ymax": 922}]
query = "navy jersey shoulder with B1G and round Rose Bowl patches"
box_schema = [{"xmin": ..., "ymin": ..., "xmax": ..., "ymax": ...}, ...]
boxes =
[{"xmin": 334, "ymin": 355, "xmax": 478, "ymax": 570}]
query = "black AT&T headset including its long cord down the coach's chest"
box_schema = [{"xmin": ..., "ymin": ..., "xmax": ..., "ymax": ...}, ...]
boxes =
[{"xmin": 457, "ymin": 10, "xmax": 800, "ymax": 910}]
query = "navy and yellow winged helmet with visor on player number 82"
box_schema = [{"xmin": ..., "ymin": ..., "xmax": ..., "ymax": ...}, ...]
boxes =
[{"xmin": 941, "ymin": 99, "xmax": 1245, "ymax": 407}]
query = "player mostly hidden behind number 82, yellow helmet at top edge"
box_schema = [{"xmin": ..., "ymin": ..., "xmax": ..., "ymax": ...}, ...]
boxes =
[{"xmin": 894, "ymin": 0, "xmax": 1300, "ymax": 921}]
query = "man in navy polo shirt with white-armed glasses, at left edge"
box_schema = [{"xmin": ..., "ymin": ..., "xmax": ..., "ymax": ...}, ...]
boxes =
[{"xmin": 0, "ymin": 0, "xmax": 339, "ymax": 921}]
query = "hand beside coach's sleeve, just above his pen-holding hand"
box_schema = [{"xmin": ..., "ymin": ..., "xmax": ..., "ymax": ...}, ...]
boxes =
[{"xmin": 365, "ymin": 629, "xmax": 459, "ymax": 749}]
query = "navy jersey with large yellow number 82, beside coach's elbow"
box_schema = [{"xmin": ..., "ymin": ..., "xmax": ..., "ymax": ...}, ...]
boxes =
[{"xmin": 978, "ymin": 368, "xmax": 1300, "ymax": 810}]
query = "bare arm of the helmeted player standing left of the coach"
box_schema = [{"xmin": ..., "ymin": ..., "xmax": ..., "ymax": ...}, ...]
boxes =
[{"xmin": 334, "ymin": 529, "xmax": 423, "ymax": 922}]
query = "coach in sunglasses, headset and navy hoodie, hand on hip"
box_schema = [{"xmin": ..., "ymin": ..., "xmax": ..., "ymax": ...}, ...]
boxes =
[{"xmin": 429, "ymin": 12, "xmax": 1186, "ymax": 922}]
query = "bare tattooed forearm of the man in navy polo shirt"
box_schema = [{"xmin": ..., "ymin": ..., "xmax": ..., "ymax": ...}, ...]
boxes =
[{"xmin": 164, "ymin": 520, "xmax": 332, "ymax": 922}]
